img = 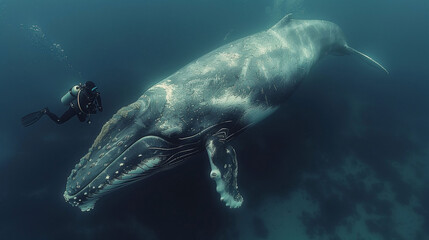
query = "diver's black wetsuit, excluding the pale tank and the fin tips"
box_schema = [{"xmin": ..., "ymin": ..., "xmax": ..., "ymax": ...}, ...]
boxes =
[{"xmin": 45, "ymin": 82, "xmax": 103, "ymax": 124}]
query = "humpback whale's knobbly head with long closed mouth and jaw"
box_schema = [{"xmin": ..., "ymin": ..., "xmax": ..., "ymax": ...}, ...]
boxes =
[{"xmin": 64, "ymin": 95, "xmax": 179, "ymax": 211}]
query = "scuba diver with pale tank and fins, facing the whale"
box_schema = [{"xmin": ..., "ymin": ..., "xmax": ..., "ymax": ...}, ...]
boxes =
[{"xmin": 21, "ymin": 81, "xmax": 103, "ymax": 127}]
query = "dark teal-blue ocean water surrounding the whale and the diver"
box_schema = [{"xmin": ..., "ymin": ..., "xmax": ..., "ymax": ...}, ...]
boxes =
[{"xmin": 0, "ymin": 0, "xmax": 429, "ymax": 240}]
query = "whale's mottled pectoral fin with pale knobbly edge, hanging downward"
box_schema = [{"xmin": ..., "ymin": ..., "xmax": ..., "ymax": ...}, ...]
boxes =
[{"xmin": 206, "ymin": 137, "xmax": 243, "ymax": 208}]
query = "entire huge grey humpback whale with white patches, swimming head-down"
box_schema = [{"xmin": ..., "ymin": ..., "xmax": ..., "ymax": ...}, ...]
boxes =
[{"xmin": 64, "ymin": 15, "xmax": 387, "ymax": 211}]
